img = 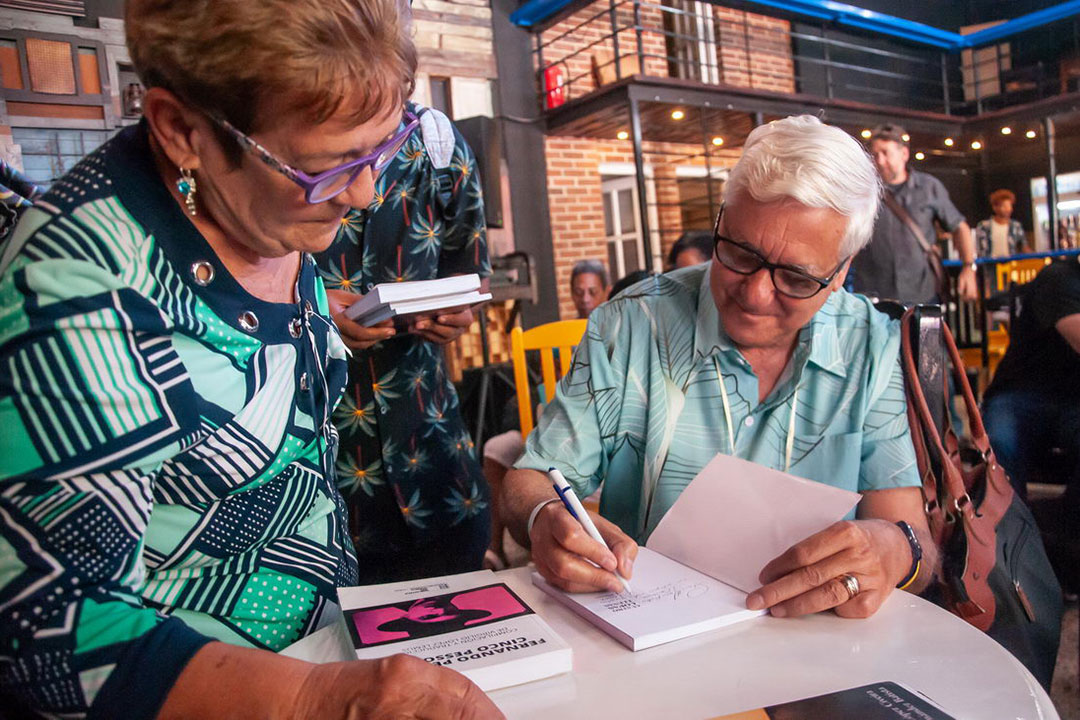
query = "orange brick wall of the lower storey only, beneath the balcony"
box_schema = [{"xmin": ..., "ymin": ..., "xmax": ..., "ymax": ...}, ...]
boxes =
[{"xmin": 544, "ymin": 137, "xmax": 740, "ymax": 320}]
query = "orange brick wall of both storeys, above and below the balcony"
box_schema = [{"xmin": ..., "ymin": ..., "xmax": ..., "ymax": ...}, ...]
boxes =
[{"xmin": 541, "ymin": 2, "xmax": 795, "ymax": 318}]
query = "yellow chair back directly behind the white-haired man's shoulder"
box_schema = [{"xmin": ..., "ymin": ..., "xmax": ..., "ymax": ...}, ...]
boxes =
[{"xmin": 510, "ymin": 320, "xmax": 588, "ymax": 437}]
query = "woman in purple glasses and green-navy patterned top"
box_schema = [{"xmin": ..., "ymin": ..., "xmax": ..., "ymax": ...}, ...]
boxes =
[{"xmin": 0, "ymin": 0, "xmax": 499, "ymax": 718}]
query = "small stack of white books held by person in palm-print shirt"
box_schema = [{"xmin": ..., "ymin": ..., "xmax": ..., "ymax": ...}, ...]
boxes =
[{"xmin": 345, "ymin": 273, "xmax": 491, "ymax": 327}]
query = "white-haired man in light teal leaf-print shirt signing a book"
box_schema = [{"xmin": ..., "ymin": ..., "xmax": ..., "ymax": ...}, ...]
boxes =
[{"xmin": 505, "ymin": 116, "xmax": 937, "ymax": 617}]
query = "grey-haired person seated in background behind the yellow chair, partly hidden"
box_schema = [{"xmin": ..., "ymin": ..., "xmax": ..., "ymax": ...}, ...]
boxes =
[{"xmin": 484, "ymin": 260, "xmax": 611, "ymax": 569}]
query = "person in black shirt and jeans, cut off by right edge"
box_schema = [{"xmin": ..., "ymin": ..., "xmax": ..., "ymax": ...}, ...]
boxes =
[{"xmin": 983, "ymin": 259, "xmax": 1080, "ymax": 515}]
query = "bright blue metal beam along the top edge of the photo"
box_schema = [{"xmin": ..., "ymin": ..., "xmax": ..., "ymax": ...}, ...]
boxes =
[{"xmin": 510, "ymin": 0, "xmax": 1080, "ymax": 52}]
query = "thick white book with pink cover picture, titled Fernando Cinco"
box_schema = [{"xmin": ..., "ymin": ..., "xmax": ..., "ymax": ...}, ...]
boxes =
[{"xmin": 338, "ymin": 570, "xmax": 572, "ymax": 691}]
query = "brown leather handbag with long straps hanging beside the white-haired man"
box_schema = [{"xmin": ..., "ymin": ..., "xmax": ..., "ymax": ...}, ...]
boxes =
[{"xmin": 901, "ymin": 308, "xmax": 1063, "ymax": 688}]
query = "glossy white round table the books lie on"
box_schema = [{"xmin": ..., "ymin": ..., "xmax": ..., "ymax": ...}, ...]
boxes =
[{"xmin": 491, "ymin": 568, "xmax": 1058, "ymax": 720}]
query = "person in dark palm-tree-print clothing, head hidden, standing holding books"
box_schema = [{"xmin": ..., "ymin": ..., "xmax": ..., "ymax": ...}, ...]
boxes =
[{"xmin": 316, "ymin": 103, "xmax": 491, "ymax": 585}]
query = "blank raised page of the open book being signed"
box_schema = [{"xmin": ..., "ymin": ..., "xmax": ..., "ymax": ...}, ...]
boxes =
[{"xmin": 634, "ymin": 454, "xmax": 861, "ymax": 593}]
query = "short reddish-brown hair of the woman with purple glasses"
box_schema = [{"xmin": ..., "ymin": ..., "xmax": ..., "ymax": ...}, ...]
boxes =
[{"xmin": 124, "ymin": 0, "xmax": 417, "ymax": 133}]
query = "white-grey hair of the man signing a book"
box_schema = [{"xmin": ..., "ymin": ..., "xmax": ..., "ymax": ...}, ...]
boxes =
[{"xmin": 725, "ymin": 116, "xmax": 881, "ymax": 258}]
